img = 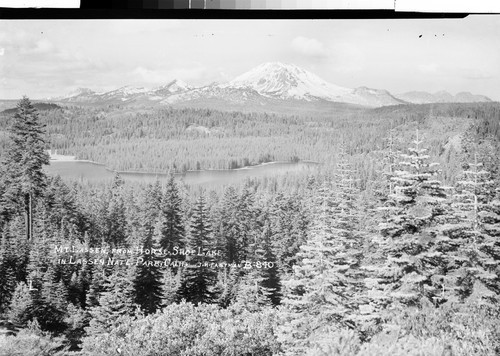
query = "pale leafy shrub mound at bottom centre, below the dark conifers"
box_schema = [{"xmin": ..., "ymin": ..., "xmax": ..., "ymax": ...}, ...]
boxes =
[{"xmin": 82, "ymin": 303, "xmax": 278, "ymax": 356}]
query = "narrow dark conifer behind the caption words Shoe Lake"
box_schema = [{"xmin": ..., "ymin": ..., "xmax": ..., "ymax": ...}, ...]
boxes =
[{"xmin": 179, "ymin": 194, "xmax": 217, "ymax": 305}]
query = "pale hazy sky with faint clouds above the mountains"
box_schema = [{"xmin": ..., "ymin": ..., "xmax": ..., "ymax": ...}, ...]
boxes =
[{"xmin": 0, "ymin": 16, "xmax": 500, "ymax": 100}]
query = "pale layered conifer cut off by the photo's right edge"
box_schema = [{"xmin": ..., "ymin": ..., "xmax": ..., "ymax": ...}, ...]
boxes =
[{"xmin": 450, "ymin": 156, "xmax": 500, "ymax": 303}]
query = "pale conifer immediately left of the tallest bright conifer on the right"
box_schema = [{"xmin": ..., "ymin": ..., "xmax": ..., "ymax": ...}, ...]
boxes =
[{"xmin": 282, "ymin": 155, "xmax": 365, "ymax": 355}]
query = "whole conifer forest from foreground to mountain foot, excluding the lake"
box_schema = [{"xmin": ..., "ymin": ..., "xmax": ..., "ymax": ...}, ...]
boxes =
[{"xmin": 0, "ymin": 98, "xmax": 500, "ymax": 356}]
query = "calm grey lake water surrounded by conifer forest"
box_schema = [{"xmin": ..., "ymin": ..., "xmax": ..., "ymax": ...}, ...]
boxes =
[{"xmin": 45, "ymin": 161, "xmax": 319, "ymax": 185}]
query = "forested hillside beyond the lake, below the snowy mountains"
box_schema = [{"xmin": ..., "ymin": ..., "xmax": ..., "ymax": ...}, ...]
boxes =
[{"xmin": 0, "ymin": 103, "xmax": 499, "ymax": 188}]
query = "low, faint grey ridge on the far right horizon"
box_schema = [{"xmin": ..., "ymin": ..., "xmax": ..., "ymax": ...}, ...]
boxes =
[{"xmin": 396, "ymin": 91, "xmax": 492, "ymax": 104}]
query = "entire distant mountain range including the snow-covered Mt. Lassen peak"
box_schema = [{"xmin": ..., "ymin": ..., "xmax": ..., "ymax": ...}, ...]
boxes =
[{"xmin": 48, "ymin": 62, "xmax": 491, "ymax": 108}]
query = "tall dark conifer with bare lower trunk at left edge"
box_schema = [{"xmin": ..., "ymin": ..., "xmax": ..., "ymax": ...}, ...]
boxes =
[{"xmin": 4, "ymin": 97, "xmax": 49, "ymax": 240}]
